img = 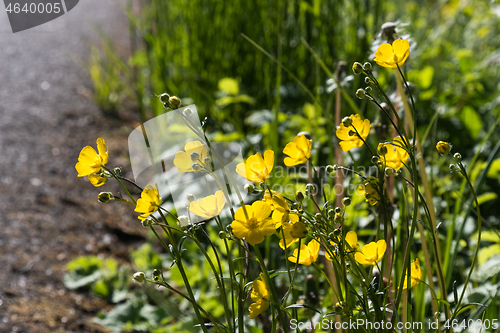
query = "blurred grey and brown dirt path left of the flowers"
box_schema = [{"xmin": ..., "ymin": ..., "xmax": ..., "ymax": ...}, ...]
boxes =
[{"xmin": 0, "ymin": 0, "xmax": 145, "ymax": 333}]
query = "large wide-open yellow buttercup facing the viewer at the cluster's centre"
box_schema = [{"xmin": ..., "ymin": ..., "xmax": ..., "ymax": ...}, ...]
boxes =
[{"xmin": 231, "ymin": 201, "xmax": 276, "ymax": 245}]
